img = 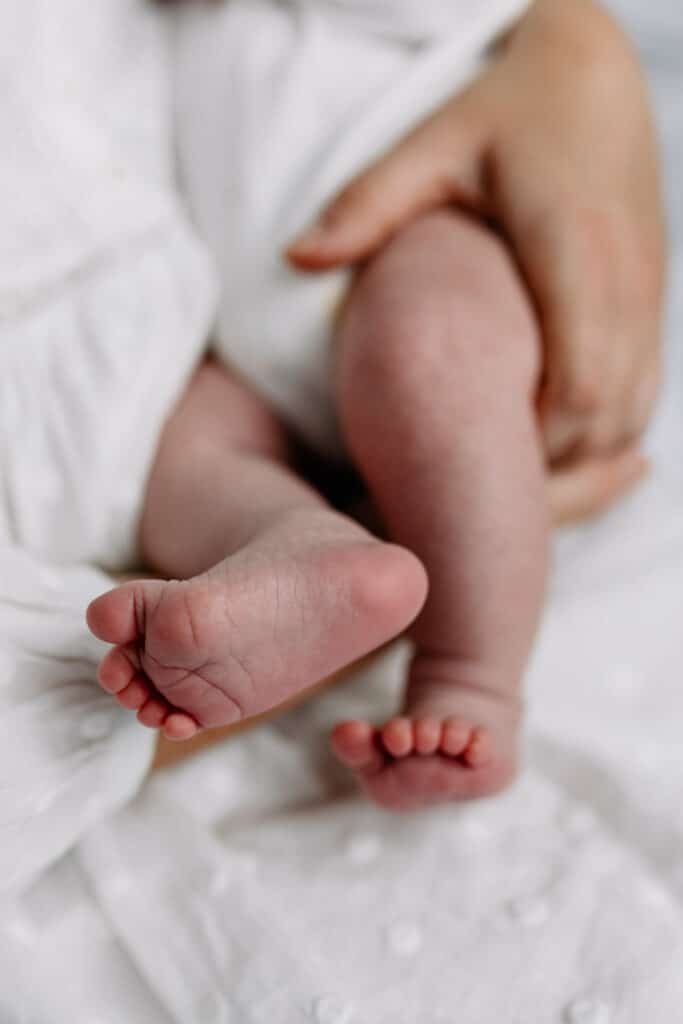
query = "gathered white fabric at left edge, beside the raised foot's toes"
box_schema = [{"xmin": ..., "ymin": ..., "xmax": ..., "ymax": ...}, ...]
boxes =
[{"xmin": 0, "ymin": 548, "xmax": 156, "ymax": 896}]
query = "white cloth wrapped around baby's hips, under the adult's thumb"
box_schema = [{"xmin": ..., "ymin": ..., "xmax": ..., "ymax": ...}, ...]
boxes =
[{"xmin": 175, "ymin": 0, "xmax": 526, "ymax": 455}]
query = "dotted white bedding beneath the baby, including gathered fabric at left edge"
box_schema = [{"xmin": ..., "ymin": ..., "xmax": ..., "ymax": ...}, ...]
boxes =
[{"xmin": 0, "ymin": 0, "xmax": 683, "ymax": 1024}]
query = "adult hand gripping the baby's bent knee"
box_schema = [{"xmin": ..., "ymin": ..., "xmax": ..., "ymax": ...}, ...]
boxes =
[{"xmin": 289, "ymin": 0, "xmax": 665, "ymax": 475}]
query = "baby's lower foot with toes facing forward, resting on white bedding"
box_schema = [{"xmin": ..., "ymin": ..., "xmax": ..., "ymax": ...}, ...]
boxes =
[{"xmin": 332, "ymin": 659, "xmax": 521, "ymax": 811}]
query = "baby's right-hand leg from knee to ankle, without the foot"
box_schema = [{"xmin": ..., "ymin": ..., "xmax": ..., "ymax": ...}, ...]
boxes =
[{"xmin": 337, "ymin": 211, "xmax": 548, "ymax": 682}]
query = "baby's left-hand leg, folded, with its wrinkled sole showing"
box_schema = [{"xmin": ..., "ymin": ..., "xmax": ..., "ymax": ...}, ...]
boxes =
[{"xmin": 88, "ymin": 364, "xmax": 426, "ymax": 739}]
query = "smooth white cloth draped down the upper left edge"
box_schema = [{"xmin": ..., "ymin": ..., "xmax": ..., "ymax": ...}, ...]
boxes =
[{"xmin": 0, "ymin": 0, "xmax": 215, "ymax": 568}]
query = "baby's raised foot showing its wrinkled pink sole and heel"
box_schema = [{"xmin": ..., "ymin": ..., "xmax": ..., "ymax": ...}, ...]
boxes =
[{"xmin": 88, "ymin": 510, "xmax": 426, "ymax": 739}]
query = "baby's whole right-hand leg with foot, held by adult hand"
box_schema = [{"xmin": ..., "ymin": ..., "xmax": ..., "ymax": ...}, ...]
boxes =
[{"xmin": 334, "ymin": 211, "xmax": 549, "ymax": 809}]
